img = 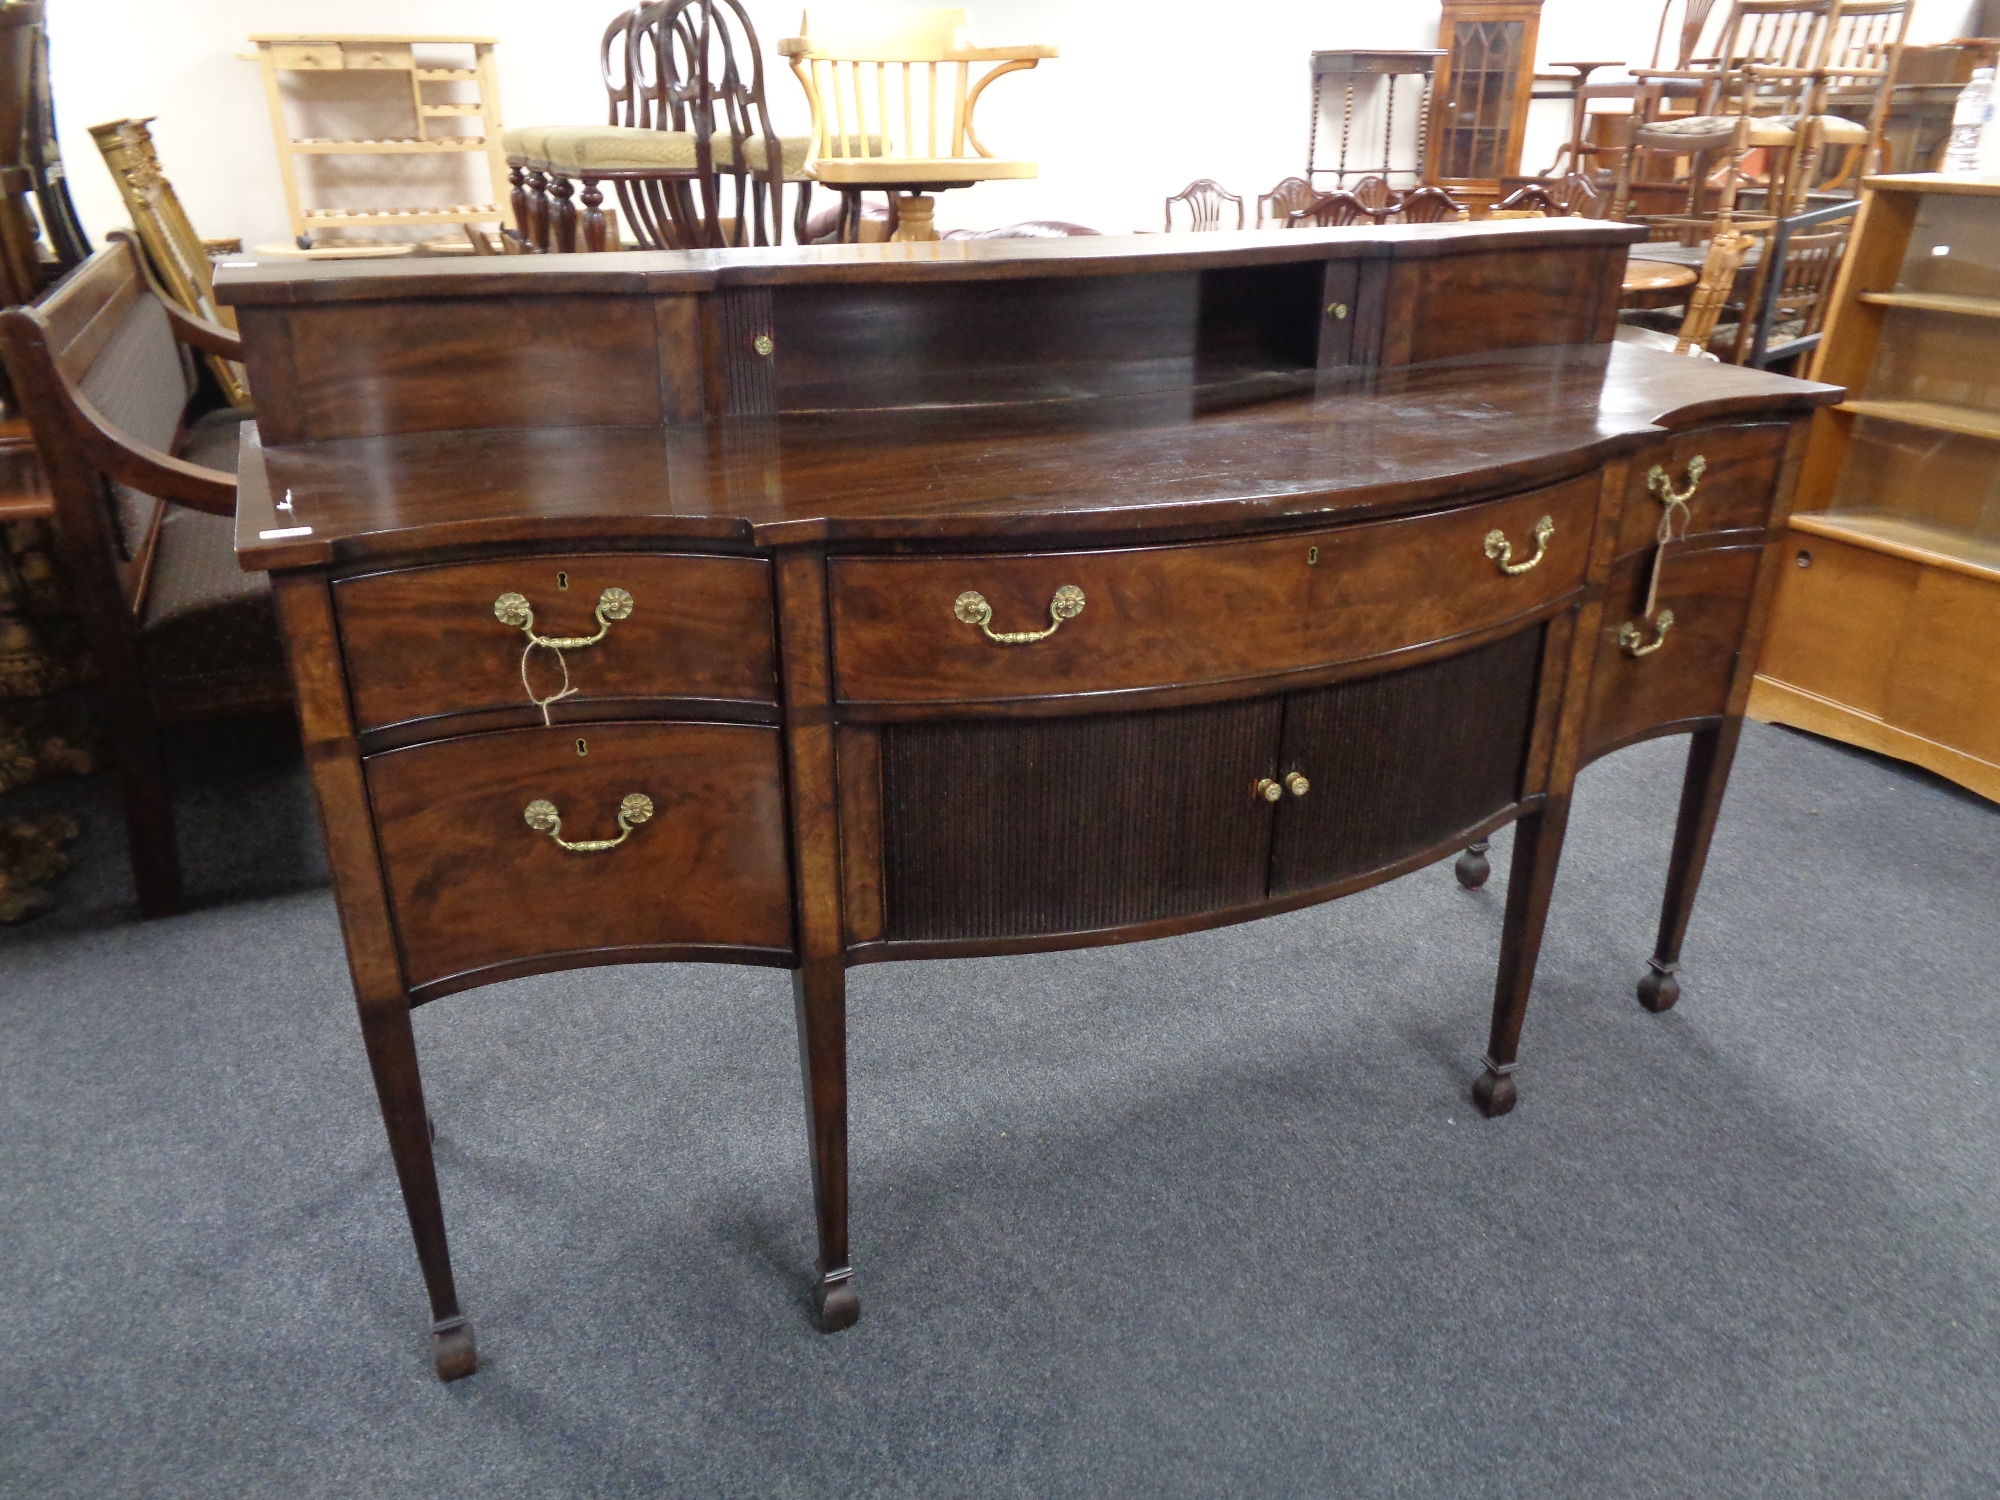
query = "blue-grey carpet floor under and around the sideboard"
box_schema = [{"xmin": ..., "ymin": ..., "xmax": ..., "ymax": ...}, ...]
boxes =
[{"xmin": 0, "ymin": 726, "xmax": 2000, "ymax": 1498}]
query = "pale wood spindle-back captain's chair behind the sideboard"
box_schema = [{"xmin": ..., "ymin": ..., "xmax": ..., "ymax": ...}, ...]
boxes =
[{"xmin": 778, "ymin": 6, "xmax": 1056, "ymax": 240}]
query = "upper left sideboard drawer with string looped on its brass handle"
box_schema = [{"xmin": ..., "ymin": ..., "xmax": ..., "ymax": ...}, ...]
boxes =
[{"xmin": 334, "ymin": 552, "xmax": 778, "ymax": 730}]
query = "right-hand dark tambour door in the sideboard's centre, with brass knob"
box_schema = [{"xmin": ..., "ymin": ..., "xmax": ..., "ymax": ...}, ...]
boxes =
[{"xmin": 1270, "ymin": 626, "xmax": 1546, "ymax": 896}]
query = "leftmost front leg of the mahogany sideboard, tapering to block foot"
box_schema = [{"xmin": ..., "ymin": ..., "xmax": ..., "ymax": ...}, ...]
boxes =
[{"xmin": 360, "ymin": 996, "xmax": 480, "ymax": 1380}]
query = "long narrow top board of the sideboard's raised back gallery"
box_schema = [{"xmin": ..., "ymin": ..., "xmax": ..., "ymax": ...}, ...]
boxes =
[{"xmin": 216, "ymin": 218, "xmax": 1646, "ymax": 308}]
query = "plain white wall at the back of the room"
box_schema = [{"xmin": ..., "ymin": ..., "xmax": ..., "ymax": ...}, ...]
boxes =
[{"xmin": 50, "ymin": 0, "xmax": 1972, "ymax": 244}]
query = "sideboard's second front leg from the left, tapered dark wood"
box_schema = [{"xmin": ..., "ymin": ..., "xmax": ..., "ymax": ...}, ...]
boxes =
[{"xmin": 792, "ymin": 958, "xmax": 862, "ymax": 1334}]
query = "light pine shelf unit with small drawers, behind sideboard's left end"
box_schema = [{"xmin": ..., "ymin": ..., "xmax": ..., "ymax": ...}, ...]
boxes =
[{"xmin": 250, "ymin": 34, "xmax": 508, "ymax": 248}]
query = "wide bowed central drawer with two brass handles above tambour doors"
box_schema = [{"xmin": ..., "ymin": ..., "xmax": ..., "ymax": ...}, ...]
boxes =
[{"xmin": 828, "ymin": 474, "xmax": 1598, "ymax": 704}]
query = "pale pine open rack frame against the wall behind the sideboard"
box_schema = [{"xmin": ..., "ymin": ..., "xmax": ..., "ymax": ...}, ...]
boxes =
[{"xmin": 250, "ymin": 32, "xmax": 508, "ymax": 248}]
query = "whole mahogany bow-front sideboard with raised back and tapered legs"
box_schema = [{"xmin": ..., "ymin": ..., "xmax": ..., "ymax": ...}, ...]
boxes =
[{"xmin": 220, "ymin": 220, "xmax": 1838, "ymax": 1380}]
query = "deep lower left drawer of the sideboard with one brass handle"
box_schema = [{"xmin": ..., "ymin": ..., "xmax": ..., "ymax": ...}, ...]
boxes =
[{"xmin": 364, "ymin": 724, "xmax": 792, "ymax": 992}]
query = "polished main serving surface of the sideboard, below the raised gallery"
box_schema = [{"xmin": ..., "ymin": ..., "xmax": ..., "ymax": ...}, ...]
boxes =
[{"xmin": 238, "ymin": 344, "xmax": 1840, "ymax": 568}]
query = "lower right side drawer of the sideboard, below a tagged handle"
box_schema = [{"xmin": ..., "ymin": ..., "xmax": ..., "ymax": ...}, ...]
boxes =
[{"xmin": 1584, "ymin": 542, "xmax": 1764, "ymax": 760}]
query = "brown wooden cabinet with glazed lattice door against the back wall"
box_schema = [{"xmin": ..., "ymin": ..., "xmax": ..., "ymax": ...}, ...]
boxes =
[{"xmin": 1424, "ymin": 0, "xmax": 1542, "ymax": 212}]
